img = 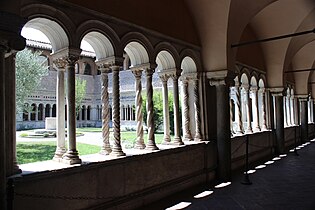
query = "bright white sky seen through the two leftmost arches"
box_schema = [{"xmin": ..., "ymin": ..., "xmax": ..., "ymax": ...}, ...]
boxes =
[{"xmin": 21, "ymin": 27, "xmax": 94, "ymax": 52}]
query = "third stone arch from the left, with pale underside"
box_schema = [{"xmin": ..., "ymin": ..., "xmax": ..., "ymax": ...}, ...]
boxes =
[{"xmin": 121, "ymin": 32, "xmax": 155, "ymax": 66}]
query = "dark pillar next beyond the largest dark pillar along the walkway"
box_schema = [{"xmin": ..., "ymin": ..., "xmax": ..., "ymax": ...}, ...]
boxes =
[{"xmin": 272, "ymin": 88, "xmax": 285, "ymax": 154}]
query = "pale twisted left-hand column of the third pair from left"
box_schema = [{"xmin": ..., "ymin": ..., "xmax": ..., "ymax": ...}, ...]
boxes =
[{"xmin": 132, "ymin": 69, "xmax": 145, "ymax": 149}]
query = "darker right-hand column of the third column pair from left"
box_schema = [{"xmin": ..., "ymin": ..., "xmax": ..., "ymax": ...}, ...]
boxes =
[{"xmin": 145, "ymin": 67, "xmax": 159, "ymax": 150}]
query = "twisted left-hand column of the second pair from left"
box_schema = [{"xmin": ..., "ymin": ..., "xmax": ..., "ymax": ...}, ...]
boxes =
[{"xmin": 99, "ymin": 64, "xmax": 112, "ymax": 155}]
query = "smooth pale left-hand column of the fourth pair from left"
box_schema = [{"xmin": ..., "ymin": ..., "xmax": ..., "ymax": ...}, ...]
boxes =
[{"xmin": 159, "ymin": 73, "xmax": 171, "ymax": 144}]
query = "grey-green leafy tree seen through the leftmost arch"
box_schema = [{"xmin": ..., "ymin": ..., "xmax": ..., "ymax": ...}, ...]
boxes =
[{"xmin": 15, "ymin": 49, "xmax": 48, "ymax": 112}]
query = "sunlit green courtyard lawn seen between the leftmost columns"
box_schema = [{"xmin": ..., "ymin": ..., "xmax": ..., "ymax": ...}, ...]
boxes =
[{"xmin": 16, "ymin": 141, "xmax": 100, "ymax": 164}]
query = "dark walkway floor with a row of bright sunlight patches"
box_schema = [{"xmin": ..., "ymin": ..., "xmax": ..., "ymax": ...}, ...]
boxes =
[{"xmin": 142, "ymin": 140, "xmax": 315, "ymax": 210}]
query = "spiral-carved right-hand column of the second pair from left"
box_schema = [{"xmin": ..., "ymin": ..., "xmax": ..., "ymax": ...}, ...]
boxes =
[{"xmin": 110, "ymin": 66, "xmax": 126, "ymax": 157}]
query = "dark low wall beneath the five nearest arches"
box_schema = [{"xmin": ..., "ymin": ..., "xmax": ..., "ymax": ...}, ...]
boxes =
[{"xmin": 13, "ymin": 143, "xmax": 216, "ymax": 210}]
